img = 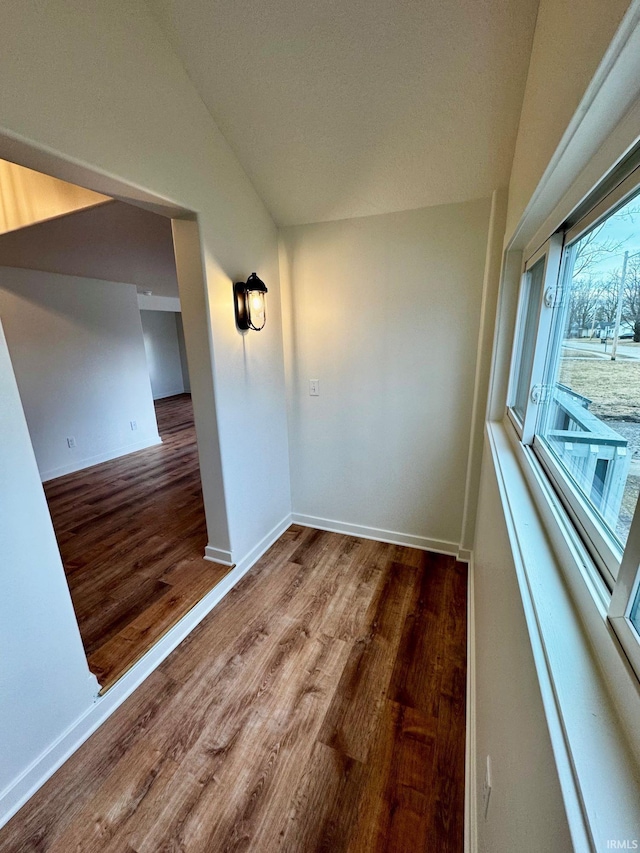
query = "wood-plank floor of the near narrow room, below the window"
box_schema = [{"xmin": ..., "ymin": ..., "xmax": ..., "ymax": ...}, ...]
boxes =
[{"xmin": 0, "ymin": 526, "xmax": 466, "ymax": 853}]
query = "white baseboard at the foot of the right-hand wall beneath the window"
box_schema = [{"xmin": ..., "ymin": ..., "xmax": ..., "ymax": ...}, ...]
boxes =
[{"xmin": 464, "ymin": 554, "xmax": 478, "ymax": 853}]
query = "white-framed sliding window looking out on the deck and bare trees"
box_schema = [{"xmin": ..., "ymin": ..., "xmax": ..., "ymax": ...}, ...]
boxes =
[{"xmin": 508, "ymin": 170, "xmax": 640, "ymax": 675}]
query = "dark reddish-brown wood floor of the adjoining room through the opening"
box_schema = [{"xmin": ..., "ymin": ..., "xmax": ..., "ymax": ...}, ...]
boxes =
[{"xmin": 44, "ymin": 394, "xmax": 229, "ymax": 690}]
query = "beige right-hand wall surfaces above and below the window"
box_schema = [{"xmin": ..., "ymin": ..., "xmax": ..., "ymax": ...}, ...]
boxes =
[{"xmin": 472, "ymin": 0, "xmax": 629, "ymax": 853}]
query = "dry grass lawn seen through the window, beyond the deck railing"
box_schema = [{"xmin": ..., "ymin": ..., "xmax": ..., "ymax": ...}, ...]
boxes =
[{"xmin": 560, "ymin": 357, "xmax": 640, "ymax": 423}]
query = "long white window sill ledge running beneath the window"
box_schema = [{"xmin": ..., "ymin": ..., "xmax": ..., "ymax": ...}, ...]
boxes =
[{"xmin": 487, "ymin": 420, "xmax": 640, "ymax": 851}]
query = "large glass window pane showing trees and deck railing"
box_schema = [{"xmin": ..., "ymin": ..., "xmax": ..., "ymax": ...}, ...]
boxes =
[{"xmin": 538, "ymin": 199, "xmax": 640, "ymax": 546}]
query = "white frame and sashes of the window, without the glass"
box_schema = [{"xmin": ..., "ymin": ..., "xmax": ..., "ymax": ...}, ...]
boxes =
[{"xmin": 506, "ymin": 167, "xmax": 640, "ymax": 679}]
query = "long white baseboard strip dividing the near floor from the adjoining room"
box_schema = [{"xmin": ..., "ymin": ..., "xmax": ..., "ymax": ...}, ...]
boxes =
[{"xmin": 0, "ymin": 515, "xmax": 291, "ymax": 828}]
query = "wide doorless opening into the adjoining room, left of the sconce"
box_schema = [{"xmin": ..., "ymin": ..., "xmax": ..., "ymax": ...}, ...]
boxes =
[{"xmin": 0, "ymin": 156, "xmax": 231, "ymax": 692}]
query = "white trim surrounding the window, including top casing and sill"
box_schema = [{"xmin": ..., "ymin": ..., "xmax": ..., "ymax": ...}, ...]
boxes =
[{"xmin": 479, "ymin": 10, "xmax": 640, "ymax": 851}]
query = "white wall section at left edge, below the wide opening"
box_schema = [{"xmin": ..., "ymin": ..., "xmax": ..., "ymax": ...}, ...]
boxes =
[{"xmin": 0, "ymin": 324, "xmax": 96, "ymax": 798}]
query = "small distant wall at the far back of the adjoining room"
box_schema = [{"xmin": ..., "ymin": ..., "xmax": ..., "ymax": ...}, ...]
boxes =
[{"xmin": 140, "ymin": 311, "xmax": 185, "ymax": 400}]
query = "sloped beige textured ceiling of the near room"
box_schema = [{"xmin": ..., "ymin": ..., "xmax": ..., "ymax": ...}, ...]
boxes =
[{"xmin": 147, "ymin": 0, "xmax": 538, "ymax": 225}]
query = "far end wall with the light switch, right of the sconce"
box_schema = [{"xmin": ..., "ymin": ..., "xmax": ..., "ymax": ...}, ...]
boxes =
[{"xmin": 281, "ymin": 199, "xmax": 490, "ymax": 550}]
